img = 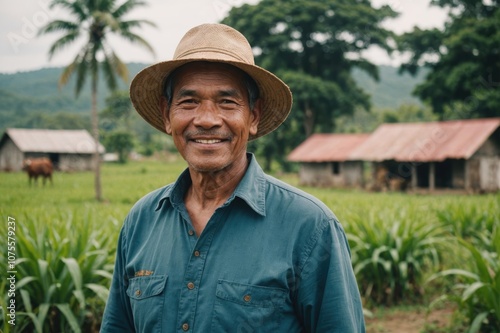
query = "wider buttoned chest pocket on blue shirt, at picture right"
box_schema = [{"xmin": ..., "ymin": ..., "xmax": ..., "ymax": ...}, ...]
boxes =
[{"xmin": 212, "ymin": 280, "xmax": 286, "ymax": 332}]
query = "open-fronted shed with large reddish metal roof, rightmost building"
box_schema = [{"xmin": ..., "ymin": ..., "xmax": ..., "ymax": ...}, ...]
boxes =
[{"xmin": 348, "ymin": 118, "xmax": 500, "ymax": 192}]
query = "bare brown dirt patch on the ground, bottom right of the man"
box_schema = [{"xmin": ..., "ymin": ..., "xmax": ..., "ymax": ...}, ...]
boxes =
[{"xmin": 366, "ymin": 308, "xmax": 453, "ymax": 333}]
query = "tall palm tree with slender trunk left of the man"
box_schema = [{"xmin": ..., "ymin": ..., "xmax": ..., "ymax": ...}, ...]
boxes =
[{"xmin": 38, "ymin": 0, "xmax": 155, "ymax": 201}]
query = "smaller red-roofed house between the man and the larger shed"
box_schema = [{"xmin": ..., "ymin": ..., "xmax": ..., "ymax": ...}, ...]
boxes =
[{"xmin": 288, "ymin": 134, "xmax": 369, "ymax": 187}]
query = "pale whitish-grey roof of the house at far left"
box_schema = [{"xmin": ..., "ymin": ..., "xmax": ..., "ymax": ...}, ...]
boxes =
[{"xmin": 6, "ymin": 128, "xmax": 105, "ymax": 154}]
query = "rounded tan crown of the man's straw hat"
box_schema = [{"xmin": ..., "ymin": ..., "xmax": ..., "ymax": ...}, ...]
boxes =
[{"xmin": 174, "ymin": 24, "xmax": 255, "ymax": 65}]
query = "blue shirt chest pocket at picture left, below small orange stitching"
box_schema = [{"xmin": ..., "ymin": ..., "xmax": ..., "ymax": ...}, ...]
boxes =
[{"xmin": 127, "ymin": 275, "xmax": 168, "ymax": 332}]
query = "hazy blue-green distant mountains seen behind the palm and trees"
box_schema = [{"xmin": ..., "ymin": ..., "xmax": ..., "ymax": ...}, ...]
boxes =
[{"xmin": 0, "ymin": 63, "xmax": 424, "ymax": 130}]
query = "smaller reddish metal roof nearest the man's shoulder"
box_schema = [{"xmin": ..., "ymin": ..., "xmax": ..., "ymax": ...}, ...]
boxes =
[{"xmin": 288, "ymin": 134, "xmax": 369, "ymax": 162}]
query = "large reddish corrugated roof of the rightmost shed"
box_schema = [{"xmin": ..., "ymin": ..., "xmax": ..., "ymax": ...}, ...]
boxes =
[{"xmin": 349, "ymin": 118, "xmax": 500, "ymax": 162}]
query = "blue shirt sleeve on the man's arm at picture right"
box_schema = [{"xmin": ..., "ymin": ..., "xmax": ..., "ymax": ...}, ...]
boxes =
[{"xmin": 295, "ymin": 220, "xmax": 365, "ymax": 333}]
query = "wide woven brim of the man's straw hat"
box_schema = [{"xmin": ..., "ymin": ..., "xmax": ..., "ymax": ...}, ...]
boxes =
[{"xmin": 130, "ymin": 56, "xmax": 292, "ymax": 140}]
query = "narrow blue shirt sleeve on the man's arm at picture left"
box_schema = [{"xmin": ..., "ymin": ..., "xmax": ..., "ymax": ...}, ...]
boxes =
[{"xmin": 100, "ymin": 223, "xmax": 135, "ymax": 333}]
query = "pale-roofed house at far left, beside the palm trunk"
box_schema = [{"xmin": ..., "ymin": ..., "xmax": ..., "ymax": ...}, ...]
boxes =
[{"xmin": 0, "ymin": 128, "xmax": 104, "ymax": 171}]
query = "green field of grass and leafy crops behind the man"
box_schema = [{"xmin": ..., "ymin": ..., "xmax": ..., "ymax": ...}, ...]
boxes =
[{"xmin": 0, "ymin": 158, "xmax": 500, "ymax": 332}]
